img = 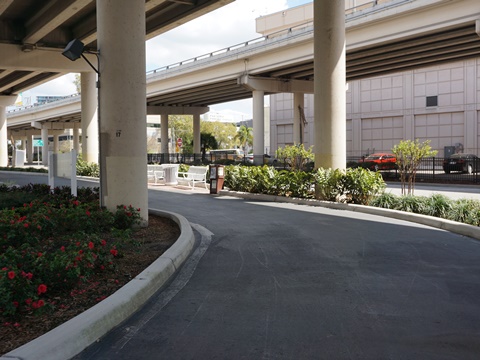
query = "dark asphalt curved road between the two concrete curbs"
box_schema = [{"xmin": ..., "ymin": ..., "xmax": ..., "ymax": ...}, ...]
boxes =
[{"xmin": 0, "ymin": 173, "xmax": 480, "ymax": 360}]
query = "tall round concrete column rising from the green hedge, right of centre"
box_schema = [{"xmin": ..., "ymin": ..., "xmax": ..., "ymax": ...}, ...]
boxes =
[{"xmin": 313, "ymin": 0, "xmax": 347, "ymax": 169}]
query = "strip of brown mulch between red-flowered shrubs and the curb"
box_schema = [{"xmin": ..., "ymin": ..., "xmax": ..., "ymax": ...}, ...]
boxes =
[{"xmin": 0, "ymin": 215, "xmax": 180, "ymax": 354}]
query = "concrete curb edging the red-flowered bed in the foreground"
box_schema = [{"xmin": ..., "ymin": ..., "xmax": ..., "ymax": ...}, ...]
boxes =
[{"xmin": 0, "ymin": 209, "xmax": 195, "ymax": 360}]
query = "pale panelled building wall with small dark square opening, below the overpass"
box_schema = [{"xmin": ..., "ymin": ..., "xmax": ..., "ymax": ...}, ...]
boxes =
[{"xmin": 270, "ymin": 58, "xmax": 480, "ymax": 157}]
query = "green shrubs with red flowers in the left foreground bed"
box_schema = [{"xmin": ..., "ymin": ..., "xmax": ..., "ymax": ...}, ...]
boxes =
[{"xmin": 0, "ymin": 186, "xmax": 140, "ymax": 318}]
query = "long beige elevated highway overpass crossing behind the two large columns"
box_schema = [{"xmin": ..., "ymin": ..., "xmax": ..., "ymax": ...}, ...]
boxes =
[{"xmin": 7, "ymin": 0, "xmax": 480, "ymax": 134}]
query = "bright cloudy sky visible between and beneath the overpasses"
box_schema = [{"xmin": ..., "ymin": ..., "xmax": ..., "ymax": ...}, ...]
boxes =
[{"xmin": 22, "ymin": 0, "xmax": 313, "ymax": 119}]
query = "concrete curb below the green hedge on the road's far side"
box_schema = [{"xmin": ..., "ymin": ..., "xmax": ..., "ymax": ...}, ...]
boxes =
[{"xmin": 220, "ymin": 190, "xmax": 480, "ymax": 240}]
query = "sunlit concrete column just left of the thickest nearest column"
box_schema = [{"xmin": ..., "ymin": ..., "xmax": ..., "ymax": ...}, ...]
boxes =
[{"xmin": 81, "ymin": 72, "xmax": 99, "ymax": 163}]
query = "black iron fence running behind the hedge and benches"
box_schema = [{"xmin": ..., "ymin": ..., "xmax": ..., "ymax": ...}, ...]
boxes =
[{"xmin": 147, "ymin": 154, "xmax": 480, "ymax": 184}]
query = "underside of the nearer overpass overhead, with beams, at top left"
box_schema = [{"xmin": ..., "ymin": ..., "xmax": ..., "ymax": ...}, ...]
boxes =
[{"xmin": 0, "ymin": 0, "xmax": 233, "ymax": 95}]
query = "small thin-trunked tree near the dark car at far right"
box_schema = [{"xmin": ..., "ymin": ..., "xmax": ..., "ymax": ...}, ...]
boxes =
[{"xmin": 392, "ymin": 139, "xmax": 437, "ymax": 195}]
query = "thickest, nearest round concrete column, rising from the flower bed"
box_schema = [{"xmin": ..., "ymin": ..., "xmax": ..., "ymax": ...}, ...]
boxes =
[{"xmin": 97, "ymin": 0, "xmax": 148, "ymax": 225}]
